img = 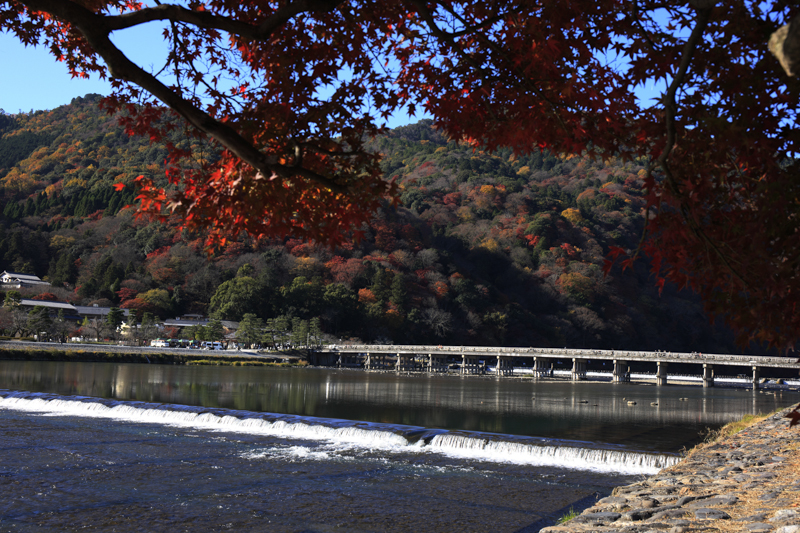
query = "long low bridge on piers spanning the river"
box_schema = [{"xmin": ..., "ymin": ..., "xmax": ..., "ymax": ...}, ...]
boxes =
[{"xmin": 311, "ymin": 344, "xmax": 800, "ymax": 388}]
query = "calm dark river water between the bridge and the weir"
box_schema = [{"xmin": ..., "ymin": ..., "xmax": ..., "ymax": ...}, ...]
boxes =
[{"xmin": 0, "ymin": 361, "xmax": 799, "ymax": 452}]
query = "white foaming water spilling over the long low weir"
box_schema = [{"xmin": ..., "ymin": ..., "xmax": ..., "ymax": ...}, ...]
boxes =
[{"xmin": 0, "ymin": 390, "xmax": 679, "ymax": 474}]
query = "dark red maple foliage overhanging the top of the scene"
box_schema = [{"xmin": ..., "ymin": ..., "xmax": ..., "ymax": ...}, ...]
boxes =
[{"xmin": 0, "ymin": 0, "xmax": 800, "ymax": 346}]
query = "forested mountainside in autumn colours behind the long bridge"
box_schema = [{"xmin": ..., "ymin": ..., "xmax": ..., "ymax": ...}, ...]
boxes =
[{"xmin": 0, "ymin": 95, "xmax": 740, "ymax": 352}]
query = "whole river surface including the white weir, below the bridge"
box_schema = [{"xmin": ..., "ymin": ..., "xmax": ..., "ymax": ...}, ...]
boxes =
[{"xmin": 0, "ymin": 361, "xmax": 800, "ymax": 532}]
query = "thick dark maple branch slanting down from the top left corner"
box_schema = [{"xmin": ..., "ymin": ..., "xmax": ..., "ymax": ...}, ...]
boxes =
[{"xmin": 19, "ymin": 0, "xmax": 346, "ymax": 193}]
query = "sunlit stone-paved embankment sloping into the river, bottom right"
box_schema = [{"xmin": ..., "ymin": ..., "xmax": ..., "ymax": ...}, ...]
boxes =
[{"xmin": 541, "ymin": 409, "xmax": 800, "ymax": 533}]
